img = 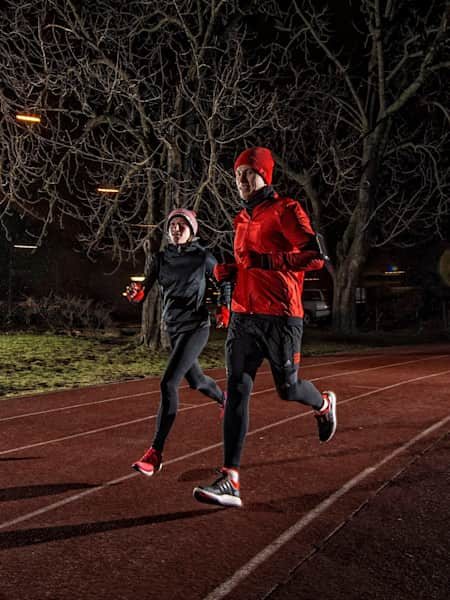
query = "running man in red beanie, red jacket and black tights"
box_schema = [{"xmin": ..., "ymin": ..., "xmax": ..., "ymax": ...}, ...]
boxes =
[{"xmin": 194, "ymin": 147, "xmax": 336, "ymax": 506}]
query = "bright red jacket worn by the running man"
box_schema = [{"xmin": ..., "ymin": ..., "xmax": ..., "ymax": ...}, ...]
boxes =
[{"xmin": 231, "ymin": 192, "xmax": 324, "ymax": 317}]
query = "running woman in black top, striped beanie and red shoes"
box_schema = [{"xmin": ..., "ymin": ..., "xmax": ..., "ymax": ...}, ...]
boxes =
[{"xmin": 126, "ymin": 208, "xmax": 231, "ymax": 477}]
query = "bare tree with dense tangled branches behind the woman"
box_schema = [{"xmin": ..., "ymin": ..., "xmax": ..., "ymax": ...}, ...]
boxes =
[{"xmin": 0, "ymin": 0, "xmax": 278, "ymax": 344}]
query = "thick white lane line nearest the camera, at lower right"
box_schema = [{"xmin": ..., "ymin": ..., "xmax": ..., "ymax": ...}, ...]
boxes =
[{"xmin": 204, "ymin": 415, "xmax": 450, "ymax": 600}]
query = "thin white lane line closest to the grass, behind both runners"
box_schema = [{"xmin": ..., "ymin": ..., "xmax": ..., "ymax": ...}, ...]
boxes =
[{"xmin": 0, "ymin": 354, "xmax": 448, "ymax": 422}]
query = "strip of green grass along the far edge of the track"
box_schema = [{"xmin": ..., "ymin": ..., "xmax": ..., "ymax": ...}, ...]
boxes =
[{"xmin": 0, "ymin": 328, "xmax": 442, "ymax": 396}]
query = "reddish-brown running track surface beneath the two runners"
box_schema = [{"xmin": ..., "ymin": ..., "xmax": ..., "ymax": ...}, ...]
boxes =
[{"xmin": 0, "ymin": 345, "xmax": 450, "ymax": 600}]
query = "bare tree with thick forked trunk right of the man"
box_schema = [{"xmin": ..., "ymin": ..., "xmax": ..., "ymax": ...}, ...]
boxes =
[{"xmin": 273, "ymin": 0, "xmax": 450, "ymax": 333}]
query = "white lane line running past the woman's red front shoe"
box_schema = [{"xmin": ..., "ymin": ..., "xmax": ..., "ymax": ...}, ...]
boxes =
[{"xmin": 0, "ymin": 370, "xmax": 450, "ymax": 529}]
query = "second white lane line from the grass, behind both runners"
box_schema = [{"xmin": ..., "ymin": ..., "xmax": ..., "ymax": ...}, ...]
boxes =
[{"xmin": 0, "ymin": 357, "xmax": 445, "ymax": 456}]
